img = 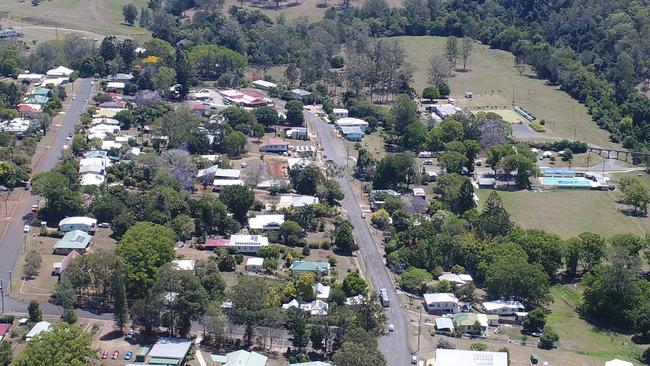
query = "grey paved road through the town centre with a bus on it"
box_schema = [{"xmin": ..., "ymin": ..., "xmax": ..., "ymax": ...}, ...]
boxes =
[{"xmin": 305, "ymin": 112, "xmax": 411, "ymax": 366}]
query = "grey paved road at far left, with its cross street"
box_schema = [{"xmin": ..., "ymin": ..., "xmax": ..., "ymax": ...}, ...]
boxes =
[{"xmin": 0, "ymin": 79, "xmax": 97, "ymax": 317}]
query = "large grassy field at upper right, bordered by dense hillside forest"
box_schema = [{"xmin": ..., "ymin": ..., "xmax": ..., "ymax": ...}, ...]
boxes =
[{"xmin": 398, "ymin": 37, "xmax": 612, "ymax": 146}]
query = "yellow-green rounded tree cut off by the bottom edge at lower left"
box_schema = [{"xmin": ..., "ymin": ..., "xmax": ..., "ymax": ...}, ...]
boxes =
[{"xmin": 12, "ymin": 323, "xmax": 96, "ymax": 366}]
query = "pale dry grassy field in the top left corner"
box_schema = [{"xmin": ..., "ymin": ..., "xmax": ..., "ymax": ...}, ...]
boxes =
[{"xmin": 0, "ymin": 0, "xmax": 148, "ymax": 40}]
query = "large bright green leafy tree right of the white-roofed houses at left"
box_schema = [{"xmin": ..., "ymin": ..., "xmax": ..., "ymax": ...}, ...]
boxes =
[{"xmin": 116, "ymin": 222, "xmax": 176, "ymax": 298}]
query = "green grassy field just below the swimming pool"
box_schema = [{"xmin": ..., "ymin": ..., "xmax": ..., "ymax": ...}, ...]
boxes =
[{"xmin": 477, "ymin": 189, "xmax": 650, "ymax": 238}]
